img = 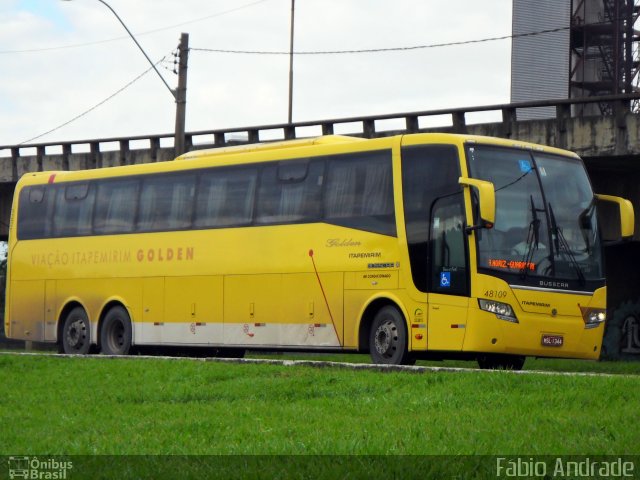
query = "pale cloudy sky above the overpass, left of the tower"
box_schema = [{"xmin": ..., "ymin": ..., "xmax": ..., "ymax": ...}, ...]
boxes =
[{"xmin": 0, "ymin": 0, "xmax": 512, "ymax": 150}]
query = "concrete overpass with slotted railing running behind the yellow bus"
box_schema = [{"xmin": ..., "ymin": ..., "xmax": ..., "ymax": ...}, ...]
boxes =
[{"xmin": 0, "ymin": 94, "xmax": 640, "ymax": 353}]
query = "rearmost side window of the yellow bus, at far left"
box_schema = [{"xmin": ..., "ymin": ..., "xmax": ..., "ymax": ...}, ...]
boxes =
[{"xmin": 18, "ymin": 185, "xmax": 55, "ymax": 240}]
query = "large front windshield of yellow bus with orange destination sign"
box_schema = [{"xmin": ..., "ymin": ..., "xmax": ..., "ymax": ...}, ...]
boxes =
[{"xmin": 467, "ymin": 145, "xmax": 603, "ymax": 286}]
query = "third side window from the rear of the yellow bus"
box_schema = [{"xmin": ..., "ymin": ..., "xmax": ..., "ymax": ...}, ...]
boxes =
[{"xmin": 93, "ymin": 179, "xmax": 140, "ymax": 234}]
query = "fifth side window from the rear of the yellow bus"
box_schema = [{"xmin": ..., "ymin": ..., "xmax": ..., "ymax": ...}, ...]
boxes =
[{"xmin": 194, "ymin": 167, "xmax": 258, "ymax": 228}]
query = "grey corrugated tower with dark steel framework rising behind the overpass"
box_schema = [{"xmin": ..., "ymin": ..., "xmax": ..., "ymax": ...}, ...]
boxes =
[{"xmin": 511, "ymin": 0, "xmax": 640, "ymax": 120}]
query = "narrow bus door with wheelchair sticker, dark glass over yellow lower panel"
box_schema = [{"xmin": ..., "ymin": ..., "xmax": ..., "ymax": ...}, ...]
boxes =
[{"xmin": 427, "ymin": 194, "xmax": 469, "ymax": 350}]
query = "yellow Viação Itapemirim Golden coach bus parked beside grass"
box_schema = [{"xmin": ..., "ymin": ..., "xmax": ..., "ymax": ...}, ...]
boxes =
[{"xmin": 5, "ymin": 134, "xmax": 633, "ymax": 368}]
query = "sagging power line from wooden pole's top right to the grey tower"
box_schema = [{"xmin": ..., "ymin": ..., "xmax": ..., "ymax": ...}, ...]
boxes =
[{"xmin": 191, "ymin": 27, "xmax": 571, "ymax": 55}]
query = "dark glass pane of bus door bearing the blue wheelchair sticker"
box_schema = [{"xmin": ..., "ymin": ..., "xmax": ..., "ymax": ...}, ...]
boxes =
[{"xmin": 431, "ymin": 194, "xmax": 469, "ymax": 295}]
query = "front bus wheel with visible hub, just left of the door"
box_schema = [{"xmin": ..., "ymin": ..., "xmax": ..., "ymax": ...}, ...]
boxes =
[{"xmin": 369, "ymin": 305, "xmax": 415, "ymax": 365}]
